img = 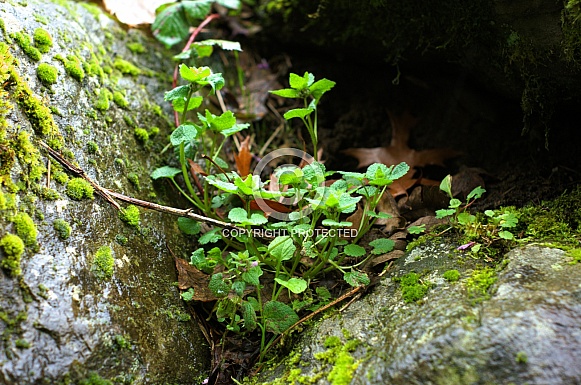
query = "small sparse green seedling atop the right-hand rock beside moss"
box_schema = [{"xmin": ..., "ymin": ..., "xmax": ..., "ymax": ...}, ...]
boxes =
[{"xmin": 436, "ymin": 175, "xmax": 518, "ymax": 253}]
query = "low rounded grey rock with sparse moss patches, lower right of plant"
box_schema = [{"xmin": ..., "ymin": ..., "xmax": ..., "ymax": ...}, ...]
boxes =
[{"xmin": 261, "ymin": 244, "xmax": 581, "ymax": 385}]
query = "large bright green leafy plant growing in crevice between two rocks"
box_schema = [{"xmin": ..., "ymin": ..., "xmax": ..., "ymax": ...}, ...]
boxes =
[{"xmin": 151, "ymin": 64, "xmax": 409, "ymax": 358}]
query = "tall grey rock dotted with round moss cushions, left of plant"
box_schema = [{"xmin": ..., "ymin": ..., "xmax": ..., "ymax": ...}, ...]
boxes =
[{"xmin": 0, "ymin": 0, "xmax": 209, "ymax": 385}]
